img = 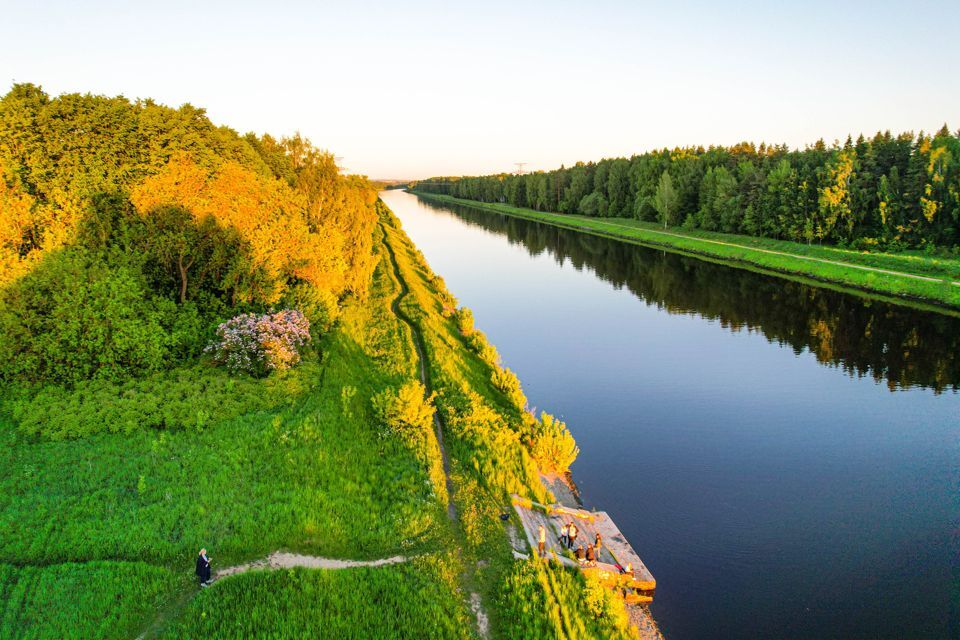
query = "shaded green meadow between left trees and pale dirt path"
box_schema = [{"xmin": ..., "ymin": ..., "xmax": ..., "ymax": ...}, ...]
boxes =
[{"xmin": 0, "ymin": 328, "xmax": 442, "ymax": 564}]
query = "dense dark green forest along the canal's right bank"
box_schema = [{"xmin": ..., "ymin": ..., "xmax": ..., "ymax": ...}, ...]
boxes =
[{"xmin": 414, "ymin": 125, "xmax": 960, "ymax": 249}]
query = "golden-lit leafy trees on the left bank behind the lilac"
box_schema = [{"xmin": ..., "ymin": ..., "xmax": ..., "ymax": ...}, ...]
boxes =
[{"xmin": 0, "ymin": 84, "xmax": 377, "ymax": 381}]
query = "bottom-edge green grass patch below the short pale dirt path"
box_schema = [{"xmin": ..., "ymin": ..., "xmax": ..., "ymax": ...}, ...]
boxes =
[{"xmin": 164, "ymin": 557, "xmax": 474, "ymax": 640}]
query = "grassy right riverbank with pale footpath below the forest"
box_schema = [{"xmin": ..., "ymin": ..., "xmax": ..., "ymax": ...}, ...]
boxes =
[{"xmin": 413, "ymin": 191, "xmax": 960, "ymax": 313}]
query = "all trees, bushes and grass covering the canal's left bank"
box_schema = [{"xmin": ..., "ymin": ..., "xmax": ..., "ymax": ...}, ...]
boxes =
[{"xmin": 0, "ymin": 85, "xmax": 648, "ymax": 640}]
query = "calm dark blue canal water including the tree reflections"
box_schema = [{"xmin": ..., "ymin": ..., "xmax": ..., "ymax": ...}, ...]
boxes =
[{"xmin": 383, "ymin": 191, "xmax": 960, "ymax": 640}]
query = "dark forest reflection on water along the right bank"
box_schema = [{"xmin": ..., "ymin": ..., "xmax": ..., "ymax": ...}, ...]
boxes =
[{"xmin": 421, "ymin": 199, "xmax": 960, "ymax": 393}]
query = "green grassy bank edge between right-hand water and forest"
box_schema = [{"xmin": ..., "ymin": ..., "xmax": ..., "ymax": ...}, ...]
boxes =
[{"xmin": 410, "ymin": 190, "xmax": 960, "ymax": 317}]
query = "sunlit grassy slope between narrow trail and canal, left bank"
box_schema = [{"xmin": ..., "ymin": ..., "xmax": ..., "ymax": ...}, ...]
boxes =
[{"xmin": 376, "ymin": 212, "xmax": 631, "ymax": 640}]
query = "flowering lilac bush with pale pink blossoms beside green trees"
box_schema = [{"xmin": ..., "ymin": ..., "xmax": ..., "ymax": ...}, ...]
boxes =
[{"xmin": 206, "ymin": 309, "xmax": 310, "ymax": 376}]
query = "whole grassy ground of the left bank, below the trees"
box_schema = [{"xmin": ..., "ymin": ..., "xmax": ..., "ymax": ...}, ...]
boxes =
[{"xmin": 0, "ymin": 210, "xmax": 626, "ymax": 639}]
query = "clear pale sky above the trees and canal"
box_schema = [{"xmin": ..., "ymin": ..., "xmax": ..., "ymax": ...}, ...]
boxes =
[{"xmin": 0, "ymin": 0, "xmax": 960, "ymax": 178}]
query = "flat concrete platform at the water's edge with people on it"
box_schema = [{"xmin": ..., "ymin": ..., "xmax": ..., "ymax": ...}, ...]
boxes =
[{"xmin": 512, "ymin": 494, "xmax": 657, "ymax": 604}]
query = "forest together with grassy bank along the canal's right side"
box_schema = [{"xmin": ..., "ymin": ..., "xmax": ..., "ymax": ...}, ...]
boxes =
[{"xmin": 410, "ymin": 125, "xmax": 960, "ymax": 310}]
